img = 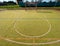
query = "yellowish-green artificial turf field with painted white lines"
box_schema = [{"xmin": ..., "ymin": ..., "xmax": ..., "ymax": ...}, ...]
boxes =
[{"xmin": 0, "ymin": 10, "xmax": 60, "ymax": 46}]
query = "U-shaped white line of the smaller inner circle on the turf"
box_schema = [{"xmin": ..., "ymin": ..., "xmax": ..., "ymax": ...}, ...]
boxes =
[{"xmin": 14, "ymin": 15, "xmax": 51, "ymax": 37}]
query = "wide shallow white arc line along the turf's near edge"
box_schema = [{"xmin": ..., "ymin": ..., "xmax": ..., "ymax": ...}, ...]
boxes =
[{"xmin": 4, "ymin": 39, "xmax": 60, "ymax": 45}]
